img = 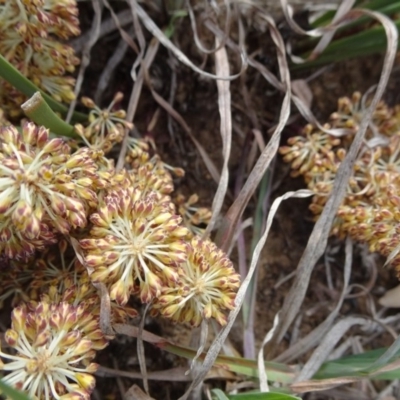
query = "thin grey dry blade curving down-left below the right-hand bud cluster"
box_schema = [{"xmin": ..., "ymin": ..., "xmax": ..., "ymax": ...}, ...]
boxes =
[{"xmin": 275, "ymin": 238, "xmax": 353, "ymax": 363}]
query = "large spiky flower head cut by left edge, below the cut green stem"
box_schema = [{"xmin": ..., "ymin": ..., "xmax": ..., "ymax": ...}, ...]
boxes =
[{"xmin": 0, "ymin": 122, "xmax": 100, "ymax": 259}]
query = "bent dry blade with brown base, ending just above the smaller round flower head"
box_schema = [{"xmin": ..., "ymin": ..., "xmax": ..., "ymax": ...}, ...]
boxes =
[{"xmin": 215, "ymin": 16, "xmax": 291, "ymax": 250}]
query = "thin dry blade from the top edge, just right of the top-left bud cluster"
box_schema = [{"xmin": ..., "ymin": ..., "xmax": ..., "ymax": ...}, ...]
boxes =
[{"xmin": 65, "ymin": 0, "xmax": 103, "ymax": 122}]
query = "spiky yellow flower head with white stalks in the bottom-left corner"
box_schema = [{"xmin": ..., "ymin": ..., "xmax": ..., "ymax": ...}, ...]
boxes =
[{"xmin": 0, "ymin": 302, "xmax": 97, "ymax": 400}]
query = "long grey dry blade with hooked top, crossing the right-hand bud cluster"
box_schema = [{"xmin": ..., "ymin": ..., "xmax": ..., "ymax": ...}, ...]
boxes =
[{"xmin": 271, "ymin": 10, "xmax": 398, "ymax": 349}]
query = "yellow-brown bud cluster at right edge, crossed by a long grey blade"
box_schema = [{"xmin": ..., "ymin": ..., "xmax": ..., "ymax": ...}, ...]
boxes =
[{"xmin": 279, "ymin": 92, "xmax": 400, "ymax": 276}]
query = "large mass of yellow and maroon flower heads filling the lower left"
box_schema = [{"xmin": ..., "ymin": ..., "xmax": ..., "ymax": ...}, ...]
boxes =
[{"xmin": 0, "ymin": 95, "xmax": 240, "ymax": 400}]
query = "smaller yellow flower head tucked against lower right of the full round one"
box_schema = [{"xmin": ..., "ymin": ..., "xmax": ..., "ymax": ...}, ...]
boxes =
[{"xmin": 154, "ymin": 236, "xmax": 240, "ymax": 326}]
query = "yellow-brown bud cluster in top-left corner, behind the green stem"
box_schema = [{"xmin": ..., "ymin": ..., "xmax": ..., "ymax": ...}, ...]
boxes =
[{"xmin": 0, "ymin": 0, "xmax": 80, "ymax": 114}]
